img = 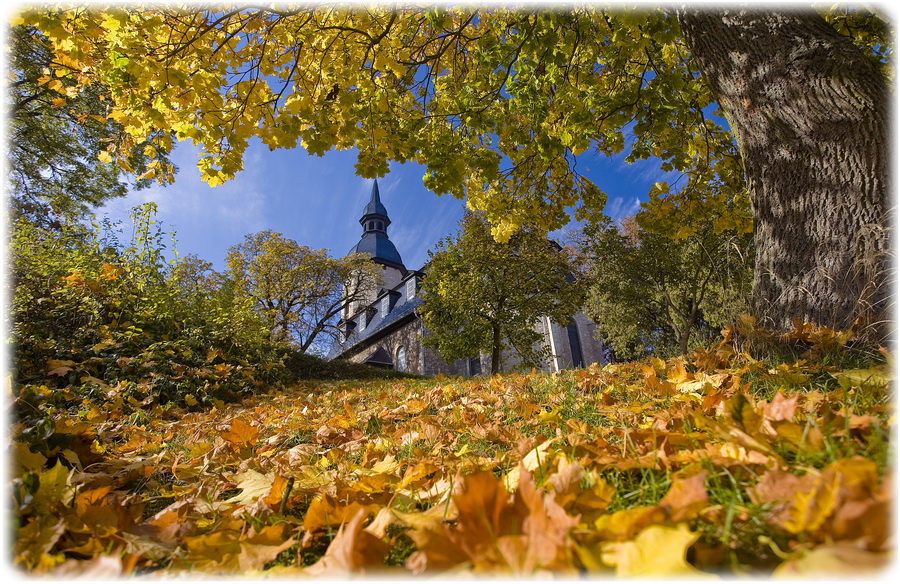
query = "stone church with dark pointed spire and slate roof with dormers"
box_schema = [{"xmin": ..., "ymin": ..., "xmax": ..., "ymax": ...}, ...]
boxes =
[{"xmin": 328, "ymin": 180, "xmax": 603, "ymax": 377}]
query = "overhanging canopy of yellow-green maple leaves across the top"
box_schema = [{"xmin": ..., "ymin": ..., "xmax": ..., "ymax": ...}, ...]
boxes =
[{"xmin": 12, "ymin": 6, "xmax": 742, "ymax": 235}]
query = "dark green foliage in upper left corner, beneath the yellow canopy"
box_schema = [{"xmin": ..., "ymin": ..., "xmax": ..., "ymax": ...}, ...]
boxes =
[{"xmin": 7, "ymin": 25, "xmax": 176, "ymax": 225}]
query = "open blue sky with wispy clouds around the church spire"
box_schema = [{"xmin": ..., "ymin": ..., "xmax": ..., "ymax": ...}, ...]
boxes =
[{"xmin": 97, "ymin": 142, "xmax": 666, "ymax": 270}]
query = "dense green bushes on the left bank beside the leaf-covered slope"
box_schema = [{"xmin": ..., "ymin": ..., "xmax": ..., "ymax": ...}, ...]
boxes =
[{"xmin": 9, "ymin": 204, "xmax": 283, "ymax": 409}]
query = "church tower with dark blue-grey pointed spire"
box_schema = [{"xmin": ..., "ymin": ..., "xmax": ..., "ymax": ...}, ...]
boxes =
[{"xmin": 344, "ymin": 179, "xmax": 408, "ymax": 318}]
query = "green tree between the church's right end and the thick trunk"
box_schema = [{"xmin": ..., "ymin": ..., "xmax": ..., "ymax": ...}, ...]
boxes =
[{"xmin": 580, "ymin": 217, "xmax": 753, "ymax": 359}]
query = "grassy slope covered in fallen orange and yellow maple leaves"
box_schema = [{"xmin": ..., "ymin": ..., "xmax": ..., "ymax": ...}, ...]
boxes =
[{"xmin": 8, "ymin": 327, "xmax": 895, "ymax": 578}]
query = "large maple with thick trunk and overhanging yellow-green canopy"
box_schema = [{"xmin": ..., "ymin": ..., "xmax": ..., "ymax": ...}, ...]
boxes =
[{"xmin": 15, "ymin": 5, "xmax": 892, "ymax": 333}]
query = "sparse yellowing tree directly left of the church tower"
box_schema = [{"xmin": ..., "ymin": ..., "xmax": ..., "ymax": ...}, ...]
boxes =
[{"xmin": 226, "ymin": 231, "xmax": 381, "ymax": 352}]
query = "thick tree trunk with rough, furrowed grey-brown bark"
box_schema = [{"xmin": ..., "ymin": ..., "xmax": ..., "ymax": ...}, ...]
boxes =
[{"xmin": 678, "ymin": 8, "xmax": 891, "ymax": 341}]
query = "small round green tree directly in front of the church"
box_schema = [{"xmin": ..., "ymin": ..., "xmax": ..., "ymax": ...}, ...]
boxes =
[{"xmin": 419, "ymin": 214, "xmax": 583, "ymax": 374}]
